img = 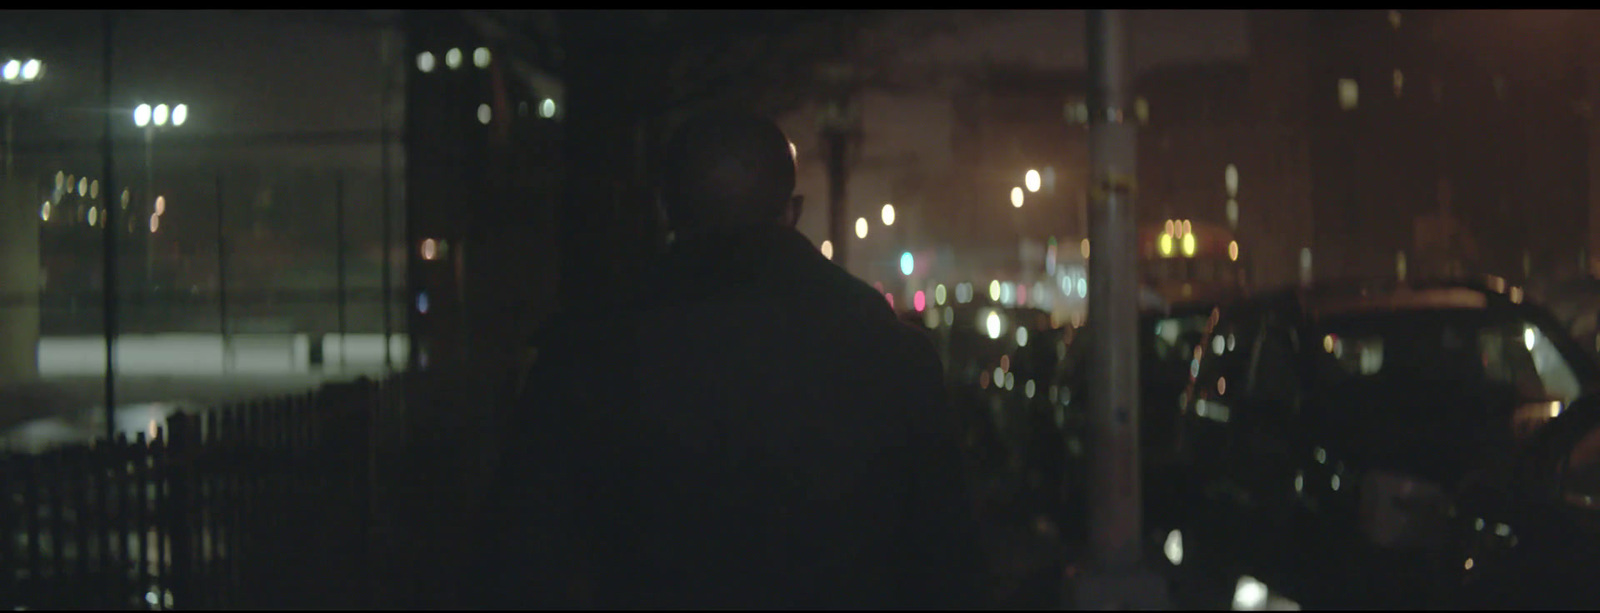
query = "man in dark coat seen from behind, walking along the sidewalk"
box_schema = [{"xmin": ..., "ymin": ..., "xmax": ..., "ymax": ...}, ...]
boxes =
[{"xmin": 467, "ymin": 115, "xmax": 984, "ymax": 608}]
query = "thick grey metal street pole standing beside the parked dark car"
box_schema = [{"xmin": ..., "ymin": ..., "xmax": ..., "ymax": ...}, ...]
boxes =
[{"xmin": 1067, "ymin": 10, "xmax": 1171, "ymax": 610}]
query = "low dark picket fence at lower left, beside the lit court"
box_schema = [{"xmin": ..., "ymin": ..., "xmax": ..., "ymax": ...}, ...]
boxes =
[{"xmin": 0, "ymin": 379, "xmax": 400, "ymax": 610}]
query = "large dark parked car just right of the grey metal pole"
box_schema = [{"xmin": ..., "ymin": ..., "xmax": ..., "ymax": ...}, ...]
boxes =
[{"xmin": 1178, "ymin": 283, "xmax": 1600, "ymax": 607}]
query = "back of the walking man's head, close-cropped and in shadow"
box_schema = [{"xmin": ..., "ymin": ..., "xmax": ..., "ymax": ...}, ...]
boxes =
[{"xmin": 662, "ymin": 112, "xmax": 795, "ymax": 234}]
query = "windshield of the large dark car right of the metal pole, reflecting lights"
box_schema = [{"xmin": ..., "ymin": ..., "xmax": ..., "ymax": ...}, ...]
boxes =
[{"xmin": 1312, "ymin": 309, "xmax": 1582, "ymax": 403}]
